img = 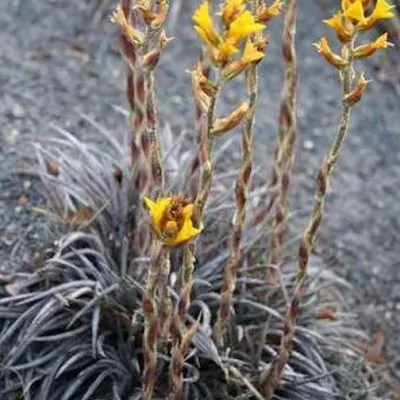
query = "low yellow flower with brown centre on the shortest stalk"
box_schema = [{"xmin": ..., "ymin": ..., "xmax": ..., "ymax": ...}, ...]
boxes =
[{"xmin": 144, "ymin": 196, "xmax": 201, "ymax": 247}]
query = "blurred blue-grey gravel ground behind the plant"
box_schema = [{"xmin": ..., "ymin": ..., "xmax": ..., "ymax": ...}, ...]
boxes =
[{"xmin": 0, "ymin": 0, "xmax": 400, "ymax": 382}]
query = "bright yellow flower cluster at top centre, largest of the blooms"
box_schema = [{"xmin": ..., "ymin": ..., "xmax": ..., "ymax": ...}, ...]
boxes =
[{"xmin": 193, "ymin": 0, "xmax": 282, "ymax": 65}]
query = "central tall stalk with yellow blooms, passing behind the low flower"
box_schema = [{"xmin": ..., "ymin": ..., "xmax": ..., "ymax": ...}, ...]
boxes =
[{"xmin": 171, "ymin": 0, "xmax": 272, "ymax": 399}]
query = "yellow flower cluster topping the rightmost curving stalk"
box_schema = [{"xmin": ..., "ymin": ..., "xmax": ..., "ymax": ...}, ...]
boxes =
[{"xmin": 315, "ymin": 0, "xmax": 395, "ymax": 69}]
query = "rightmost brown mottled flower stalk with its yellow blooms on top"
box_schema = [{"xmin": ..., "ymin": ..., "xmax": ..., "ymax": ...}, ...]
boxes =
[{"xmin": 260, "ymin": 0, "xmax": 390, "ymax": 399}]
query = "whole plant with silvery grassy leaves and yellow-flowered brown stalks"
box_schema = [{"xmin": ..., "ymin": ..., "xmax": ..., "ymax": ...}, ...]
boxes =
[{"xmin": 0, "ymin": 0, "xmax": 392, "ymax": 400}]
